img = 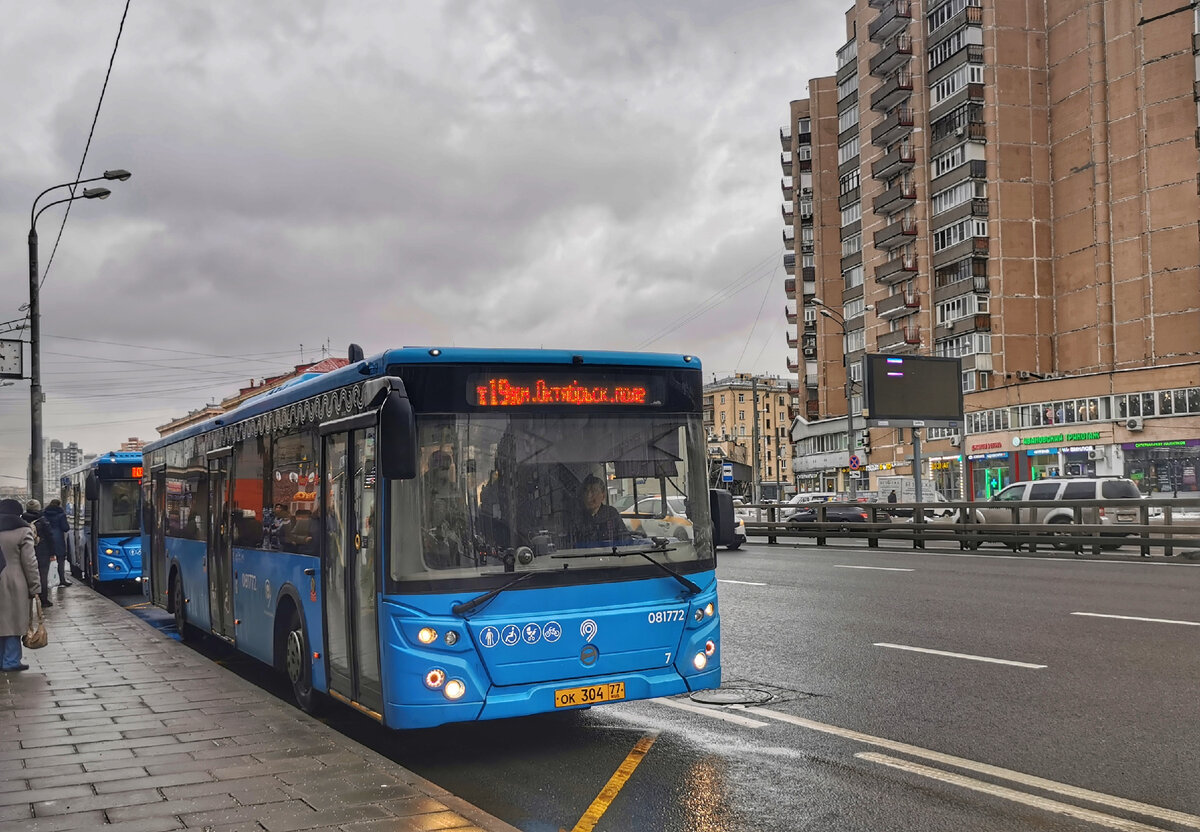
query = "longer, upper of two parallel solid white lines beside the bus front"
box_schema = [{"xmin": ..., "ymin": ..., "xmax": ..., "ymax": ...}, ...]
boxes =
[{"xmin": 745, "ymin": 707, "xmax": 1200, "ymax": 830}]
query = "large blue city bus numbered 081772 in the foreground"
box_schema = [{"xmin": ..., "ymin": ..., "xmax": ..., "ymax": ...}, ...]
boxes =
[{"xmin": 143, "ymin": 346, "xmax": 733, "ymax": 729}]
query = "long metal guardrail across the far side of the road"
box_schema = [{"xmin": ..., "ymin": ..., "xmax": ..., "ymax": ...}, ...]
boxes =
[{"xmin": 738, "ymin": 498, "xmax": 1200, "ymax": 556}]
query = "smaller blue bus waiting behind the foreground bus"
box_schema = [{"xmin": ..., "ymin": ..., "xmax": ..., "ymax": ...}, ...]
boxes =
[{"xmin": 59, "ymin": 450, "xmax": 142, "ymax": 586}]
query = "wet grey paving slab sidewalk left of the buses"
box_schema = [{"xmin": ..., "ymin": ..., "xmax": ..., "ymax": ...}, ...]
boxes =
[{"xmin": 0, "ymin": 582, "xmax": 517, "ymax": 832}]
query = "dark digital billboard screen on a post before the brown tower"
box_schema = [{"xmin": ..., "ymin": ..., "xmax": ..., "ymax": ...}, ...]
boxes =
[{"xmin": 863, "ymin": 355, "xmax": 962, "ymax": 427}]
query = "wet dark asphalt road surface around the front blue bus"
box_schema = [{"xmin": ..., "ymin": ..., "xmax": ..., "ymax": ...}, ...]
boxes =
[{"xmin": 105, "ymin": 544, "xmax": 1200, "ymax": 832}]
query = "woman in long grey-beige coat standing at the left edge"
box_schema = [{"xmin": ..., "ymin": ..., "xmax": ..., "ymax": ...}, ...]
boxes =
[{"xmin": 0, "ymin": 499, "xmax": 42, "ymax": 671}]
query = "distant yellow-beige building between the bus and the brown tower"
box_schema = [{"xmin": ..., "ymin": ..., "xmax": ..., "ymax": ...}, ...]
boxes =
[{"xmin": 703, "ymin": 372, "xmax": 796, "ymax": 499}]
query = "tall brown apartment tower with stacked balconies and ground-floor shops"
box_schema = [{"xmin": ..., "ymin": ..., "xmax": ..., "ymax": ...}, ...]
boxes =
[{"xmin": 781, "ymin": 0, "xmax": 1200, "ymax": 498}]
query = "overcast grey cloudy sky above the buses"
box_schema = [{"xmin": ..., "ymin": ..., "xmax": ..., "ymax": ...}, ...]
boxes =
[{"xmin": 0, "ymin": 0, "xmax": 850, "ymax": 485}]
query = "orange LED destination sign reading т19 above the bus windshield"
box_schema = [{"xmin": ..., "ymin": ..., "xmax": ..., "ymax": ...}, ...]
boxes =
[{"xmin": 467, "ymin": 373, "xmax": 661, "ymax": 407}]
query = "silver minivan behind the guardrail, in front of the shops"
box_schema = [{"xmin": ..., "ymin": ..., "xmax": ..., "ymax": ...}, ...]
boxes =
[{"xmin": 976, "ymin": 477, "xmax": 1141, "ymax": 545}]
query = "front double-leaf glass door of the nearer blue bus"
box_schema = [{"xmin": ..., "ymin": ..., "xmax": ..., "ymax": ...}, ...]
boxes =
[{"xmin": 322, "ymin": 427, "xmax": 383, "ymax": 719}]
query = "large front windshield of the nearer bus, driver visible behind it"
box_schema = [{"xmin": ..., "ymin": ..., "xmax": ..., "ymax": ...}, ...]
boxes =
[{"xmin": 389, "ymin": 413, "xmax": 713, "ymax": 581}]
